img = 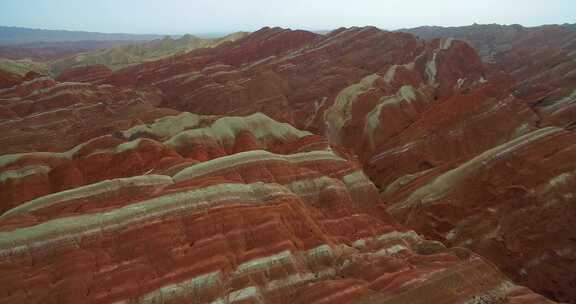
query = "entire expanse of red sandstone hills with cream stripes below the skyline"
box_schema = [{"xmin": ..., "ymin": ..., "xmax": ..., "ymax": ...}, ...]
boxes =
[{"xmin": 0, "ymin": 27, "xmax": 576, "ymax": 303}]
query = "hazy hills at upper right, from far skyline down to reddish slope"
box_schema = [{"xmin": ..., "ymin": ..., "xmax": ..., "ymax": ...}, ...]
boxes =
[{"xmin": 402, "ymin": 24, "xmax": 576, "ymax": 127}]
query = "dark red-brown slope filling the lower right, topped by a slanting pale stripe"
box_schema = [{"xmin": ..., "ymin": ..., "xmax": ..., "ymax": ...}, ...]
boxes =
[{"xmin": 384, "ymin": 127, "xmax": 576, "ymax": 300}]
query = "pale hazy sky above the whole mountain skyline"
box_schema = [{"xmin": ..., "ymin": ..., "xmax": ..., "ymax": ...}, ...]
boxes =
[{"xmin": 0, "ymin": 0, "xmax": 576, "ymax": 34}]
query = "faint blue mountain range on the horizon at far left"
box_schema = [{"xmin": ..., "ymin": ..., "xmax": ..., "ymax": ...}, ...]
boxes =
[{"xmin": 0, "ymin": 26, "xmax": 170, "ymax": 45}]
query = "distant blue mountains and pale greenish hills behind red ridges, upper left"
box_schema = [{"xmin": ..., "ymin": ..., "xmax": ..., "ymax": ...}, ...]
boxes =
[{"xmin": 0, "ymin": 26, "xmax": 248, "ymax": 75}]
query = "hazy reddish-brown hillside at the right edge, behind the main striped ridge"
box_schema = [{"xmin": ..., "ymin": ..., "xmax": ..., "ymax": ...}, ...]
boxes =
[{"xmin": 497, "ymin": 27, "xmax": 576, "ymax": 128}]
